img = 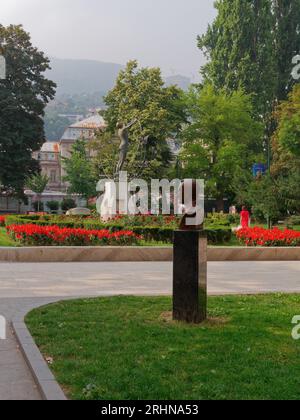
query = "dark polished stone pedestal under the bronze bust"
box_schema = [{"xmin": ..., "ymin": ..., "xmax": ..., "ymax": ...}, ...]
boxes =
[{"xmin": 173, "ymin": 230, "xmax": 207, "ymax": 323}]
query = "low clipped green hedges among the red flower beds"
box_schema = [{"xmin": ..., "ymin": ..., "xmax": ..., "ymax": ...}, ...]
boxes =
[{"xmin": 6, "ymin": 215, "xmax": 232, "ymax": 244}]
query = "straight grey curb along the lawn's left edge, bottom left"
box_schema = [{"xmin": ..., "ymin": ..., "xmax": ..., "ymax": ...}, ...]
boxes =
[{"xmin": 12, "ymin": 305, "xmax": 67, "ymax": 401}]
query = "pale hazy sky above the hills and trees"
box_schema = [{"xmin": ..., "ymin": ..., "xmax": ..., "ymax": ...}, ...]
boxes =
[{"xmin": 0, "ymin": 0, "xmax": 215, "ymax": 77}]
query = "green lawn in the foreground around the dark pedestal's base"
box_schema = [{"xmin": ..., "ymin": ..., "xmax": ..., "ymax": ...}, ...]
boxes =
[{"xmin": 26, "ymin": 294, "xmax": 300, "ymax": 400}]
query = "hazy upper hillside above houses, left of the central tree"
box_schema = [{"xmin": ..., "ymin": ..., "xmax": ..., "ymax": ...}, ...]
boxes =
[{"xmin": 47, "ymin": 58, "xmax": 123, "ymax": 95}]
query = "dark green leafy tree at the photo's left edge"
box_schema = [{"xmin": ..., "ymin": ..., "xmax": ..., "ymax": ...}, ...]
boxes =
[{"xmin": 0, "ymin": 25, "xmax": 55, "ymax": 196}]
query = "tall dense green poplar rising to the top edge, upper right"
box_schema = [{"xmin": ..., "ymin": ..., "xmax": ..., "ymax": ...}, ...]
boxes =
[{"xmin": 198, "ymin": 0, "xmax": 277, "ymax": 115}]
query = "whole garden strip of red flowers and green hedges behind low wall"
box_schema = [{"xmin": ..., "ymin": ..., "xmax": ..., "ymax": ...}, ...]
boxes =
[{"xmin": 0, "ymin": 214, "xmax": 300, "ymax": 247}]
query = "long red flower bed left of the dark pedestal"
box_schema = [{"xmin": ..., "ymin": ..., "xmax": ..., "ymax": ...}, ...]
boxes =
[{"xmin": 6, "ymin": 225, "xmax": 142, "ymax": 246}]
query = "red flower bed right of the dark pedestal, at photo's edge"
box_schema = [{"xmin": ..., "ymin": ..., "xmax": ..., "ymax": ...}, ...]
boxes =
[{"xmin": 236, "ymin": 227, "xmax": 300, "ymax": 247}]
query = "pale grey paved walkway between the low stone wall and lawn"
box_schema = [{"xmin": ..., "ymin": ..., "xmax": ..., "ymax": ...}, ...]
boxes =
[{"xmin": 0, "ymin": 262, "xmax": 300, "ymax": 400}]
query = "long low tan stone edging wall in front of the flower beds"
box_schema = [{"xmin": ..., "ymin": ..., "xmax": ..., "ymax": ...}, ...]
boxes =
[{"xmin": 0, "ymin": 247, "xmax": 300, "ymax": 263}]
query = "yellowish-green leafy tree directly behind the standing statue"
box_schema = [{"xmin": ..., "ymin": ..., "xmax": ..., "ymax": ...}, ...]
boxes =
[{"xmin": 96, "ymin": 61, "xmax": 186, "ymax": 178}]
